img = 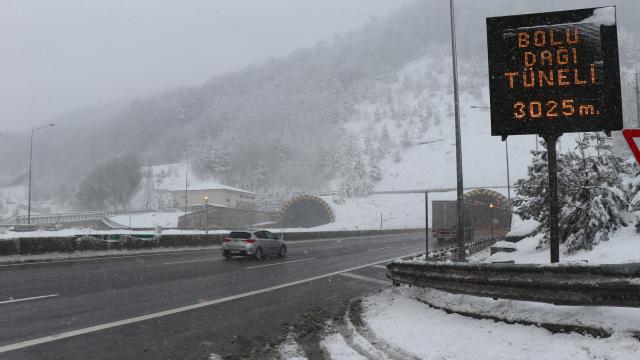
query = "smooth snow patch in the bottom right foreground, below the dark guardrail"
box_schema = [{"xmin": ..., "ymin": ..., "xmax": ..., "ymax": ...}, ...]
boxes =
[{"xmin": 363, "ymin": 289, "xmax": 640, "ymax": 360}]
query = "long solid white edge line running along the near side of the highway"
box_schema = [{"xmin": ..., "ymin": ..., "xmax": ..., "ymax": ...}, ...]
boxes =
[{"xmin": 0, "ymin": 252, "xmax": 422, "ymax": 354}]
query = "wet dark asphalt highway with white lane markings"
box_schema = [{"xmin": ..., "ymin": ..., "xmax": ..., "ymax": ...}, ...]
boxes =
[{"xmin": 0, "ymin": 233, "xmax": 436, "ymax": 359}]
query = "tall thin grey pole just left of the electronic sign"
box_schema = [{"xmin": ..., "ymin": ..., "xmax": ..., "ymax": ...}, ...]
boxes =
[{"xmin": 449, "ymin": 0, "xmax": 466, "ymax": 261}]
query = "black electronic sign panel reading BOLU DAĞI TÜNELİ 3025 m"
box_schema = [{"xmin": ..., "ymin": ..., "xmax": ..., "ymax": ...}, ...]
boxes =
[{"xmin": 487, "ymin": 7, "xmax": 622, "ymax": 138}]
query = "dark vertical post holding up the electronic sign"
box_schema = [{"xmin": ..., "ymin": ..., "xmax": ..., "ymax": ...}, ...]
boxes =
[{"xmin": 544, "ymin": 134, "xmax": 560, "ymax": 263}]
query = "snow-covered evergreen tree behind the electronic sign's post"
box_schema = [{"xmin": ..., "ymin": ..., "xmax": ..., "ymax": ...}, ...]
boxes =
[{"xmin": 514, "ymin": 133, "xmax": 628, "ymax": 253}]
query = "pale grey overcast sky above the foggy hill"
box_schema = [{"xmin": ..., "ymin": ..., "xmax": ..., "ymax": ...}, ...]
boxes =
[{"xmin": 0, "ymin": 0, "xmax": 409, "ymax": 131}]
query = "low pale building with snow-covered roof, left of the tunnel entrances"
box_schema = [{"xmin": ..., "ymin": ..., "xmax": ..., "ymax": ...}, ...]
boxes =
[{"xmin": 169, "ymin": 184, "xmax": 258, "ymax": 209}]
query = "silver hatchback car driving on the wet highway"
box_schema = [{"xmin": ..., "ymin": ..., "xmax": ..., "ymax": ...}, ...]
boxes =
[{"xmin": 222, "ymin": 230, "xmax": 287, "ymax": 259}]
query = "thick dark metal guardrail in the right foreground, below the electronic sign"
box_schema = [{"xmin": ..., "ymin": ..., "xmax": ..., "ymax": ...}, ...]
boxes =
[{"xmin": 387, "ymin": 261, "xmax": 640, "ymax": 307}]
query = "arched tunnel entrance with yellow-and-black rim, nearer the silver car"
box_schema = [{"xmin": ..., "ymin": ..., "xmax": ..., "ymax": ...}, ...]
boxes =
[{"xmin": 277, "ymin": 195, "xmax": 335, "ymax": 228}]
